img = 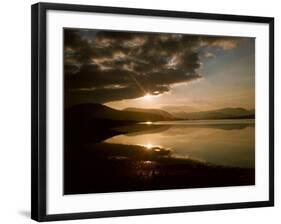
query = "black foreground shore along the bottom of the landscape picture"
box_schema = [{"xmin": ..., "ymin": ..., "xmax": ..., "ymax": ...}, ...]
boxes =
[{"xmin": 64, "ymin": 143, "xmax": 255, "ymax": 194}]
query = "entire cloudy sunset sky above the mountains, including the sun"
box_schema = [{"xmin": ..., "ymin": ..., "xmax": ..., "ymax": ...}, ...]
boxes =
[{"xmin": 64, "ymin": 29, "xmax": 255, "ymax": 112}]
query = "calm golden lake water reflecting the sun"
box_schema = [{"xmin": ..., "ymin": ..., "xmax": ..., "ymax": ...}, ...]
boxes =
[{"xmin": 105, "ymin": 119, "xmax": 255, "ymax": 168}]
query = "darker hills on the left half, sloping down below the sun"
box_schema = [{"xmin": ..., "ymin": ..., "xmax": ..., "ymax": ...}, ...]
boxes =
[{"xmin": 65, "ymin": 104, "xmax": 171, "ymax": 122}]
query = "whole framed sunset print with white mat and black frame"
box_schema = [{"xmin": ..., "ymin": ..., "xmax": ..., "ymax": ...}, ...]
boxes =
[{"xmin": 32, "ymin": 3, "xmax": 274, "ymax": 221}]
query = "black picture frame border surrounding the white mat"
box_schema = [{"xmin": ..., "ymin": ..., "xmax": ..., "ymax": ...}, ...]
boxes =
[{"xmin": 31, "ymin": 3, "xmax": 274, "ymax": 221}]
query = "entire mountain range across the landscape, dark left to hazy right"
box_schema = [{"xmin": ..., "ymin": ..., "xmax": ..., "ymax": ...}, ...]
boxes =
[{"xmin": 65, "ymin": 104, "xmax": 255, "ymax": 122}]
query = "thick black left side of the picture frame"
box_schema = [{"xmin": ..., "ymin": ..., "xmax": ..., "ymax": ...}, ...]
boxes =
[{"xmin": 31, "ymin": 3, "xmax": 47, "ymax": 222}]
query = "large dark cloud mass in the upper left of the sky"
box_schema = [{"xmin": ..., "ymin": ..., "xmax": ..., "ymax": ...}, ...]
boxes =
[{"xmin": 64, "ymin": 29, "xmax": 243, "ymax": 105}]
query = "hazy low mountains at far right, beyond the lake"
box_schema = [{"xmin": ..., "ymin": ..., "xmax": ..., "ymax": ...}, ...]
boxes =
[{"xmin": 172, "ymin": 107, "xmax": 255, "ymax": 120}]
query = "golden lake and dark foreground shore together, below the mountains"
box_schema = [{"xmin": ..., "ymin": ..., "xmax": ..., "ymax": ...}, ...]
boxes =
[{"xmin": 64, "ymin": 120, "xmax": 255, "ymax": 194}]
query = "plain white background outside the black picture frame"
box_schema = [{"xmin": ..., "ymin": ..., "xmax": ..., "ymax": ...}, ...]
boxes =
[{"xmin": 0, "ymin": 0, "xmax": 281, "ymax": 224}]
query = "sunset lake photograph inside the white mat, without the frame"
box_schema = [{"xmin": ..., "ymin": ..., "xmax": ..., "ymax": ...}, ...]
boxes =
[{"xmin": 63, "ymin": 27, "xmax": 255, "ymax": 195}]
